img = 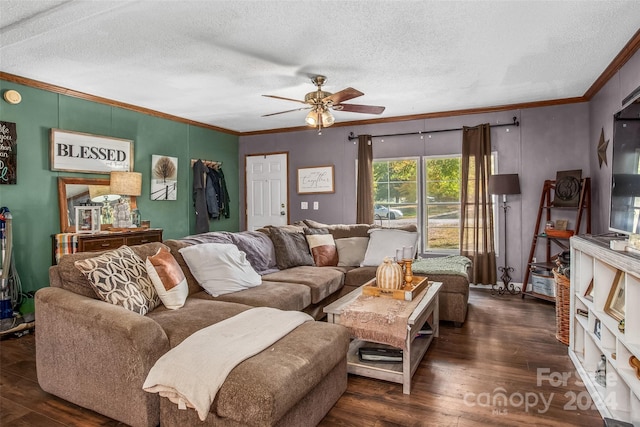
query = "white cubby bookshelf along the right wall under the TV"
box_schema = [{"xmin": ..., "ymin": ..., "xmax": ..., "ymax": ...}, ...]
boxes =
[{"xmin": 569, "ymin": 236, "xmax": 640, "ymax": 427}]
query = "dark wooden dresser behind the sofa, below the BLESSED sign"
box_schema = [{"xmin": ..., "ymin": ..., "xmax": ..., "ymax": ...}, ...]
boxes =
[{"xmin": 52, "ymin": 228, "xmax": 162, "ymax": 264}]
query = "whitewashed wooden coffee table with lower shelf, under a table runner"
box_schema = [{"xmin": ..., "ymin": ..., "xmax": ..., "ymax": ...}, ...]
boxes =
[{"xmin": 324, "ymin": 282, "xmax": 442, "ymax": 394}]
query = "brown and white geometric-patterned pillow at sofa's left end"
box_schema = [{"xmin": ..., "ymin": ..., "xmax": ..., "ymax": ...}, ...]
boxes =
[{"xmin": 74, "ymin": 246, "xmax": 160, "ymax": 315}]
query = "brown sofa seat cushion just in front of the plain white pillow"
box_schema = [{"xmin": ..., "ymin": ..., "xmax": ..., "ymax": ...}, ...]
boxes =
[{"xmin": 192, "ymin": 280, "xmax": 311, "ymax": 311}]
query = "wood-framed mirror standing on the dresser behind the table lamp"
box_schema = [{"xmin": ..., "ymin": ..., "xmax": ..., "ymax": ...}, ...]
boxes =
[{"xmin": 58, "ymin": 177, "xmax": 136, "ymax": 233}]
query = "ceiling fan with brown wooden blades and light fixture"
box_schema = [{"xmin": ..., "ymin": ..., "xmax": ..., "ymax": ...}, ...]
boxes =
[{"xmin": 262, "ymin": 75, "xmax": 385, "ymax": 134}]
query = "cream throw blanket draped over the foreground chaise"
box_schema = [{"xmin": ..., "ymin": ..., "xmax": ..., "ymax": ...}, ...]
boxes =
[{"xmin": 142, "ymin": 307, "xmax": 313, "ymax": 421}]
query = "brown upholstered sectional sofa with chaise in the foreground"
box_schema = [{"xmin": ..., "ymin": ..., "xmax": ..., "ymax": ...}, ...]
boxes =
[{"xmin": 36, "ymin": 221, "xmax": 468, "ymax": 426}]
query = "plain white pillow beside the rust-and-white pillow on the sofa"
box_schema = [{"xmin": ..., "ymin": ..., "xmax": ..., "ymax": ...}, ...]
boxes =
[{"xmin": 179, "ymin": 243, "xmax": 262, "ymax": 297}]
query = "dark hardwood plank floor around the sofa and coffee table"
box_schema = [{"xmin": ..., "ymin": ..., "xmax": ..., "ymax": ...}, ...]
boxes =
[{"xmin": 0, "ymin": 289, "xmax": 603, "ymax": 427}]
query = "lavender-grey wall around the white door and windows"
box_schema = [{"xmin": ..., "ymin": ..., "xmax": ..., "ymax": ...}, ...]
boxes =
[{"xmin": 239, "ymin": 47, "xmax": 640, "ymax": 282}]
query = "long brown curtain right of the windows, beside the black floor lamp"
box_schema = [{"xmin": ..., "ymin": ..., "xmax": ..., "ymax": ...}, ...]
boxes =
[{"xmin": 460, "ymin": 123, "xmax": 497, "ymax": 285}]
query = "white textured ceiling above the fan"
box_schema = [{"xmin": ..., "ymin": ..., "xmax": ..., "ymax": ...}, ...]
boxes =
[{"xmin": 0, "ymin": 0, "xmax": 640, "ymax": 132}]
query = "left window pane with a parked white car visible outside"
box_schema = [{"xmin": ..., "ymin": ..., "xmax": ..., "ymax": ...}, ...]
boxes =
[{"xmin": 373, "ymin": 158, "xmax": 418, "ymax": 225}]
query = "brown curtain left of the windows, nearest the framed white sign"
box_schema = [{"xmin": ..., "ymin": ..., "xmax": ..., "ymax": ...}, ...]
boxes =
[{"xmin": 356, "ymin": 135, "xmax": 373, "ymax": 224}]
